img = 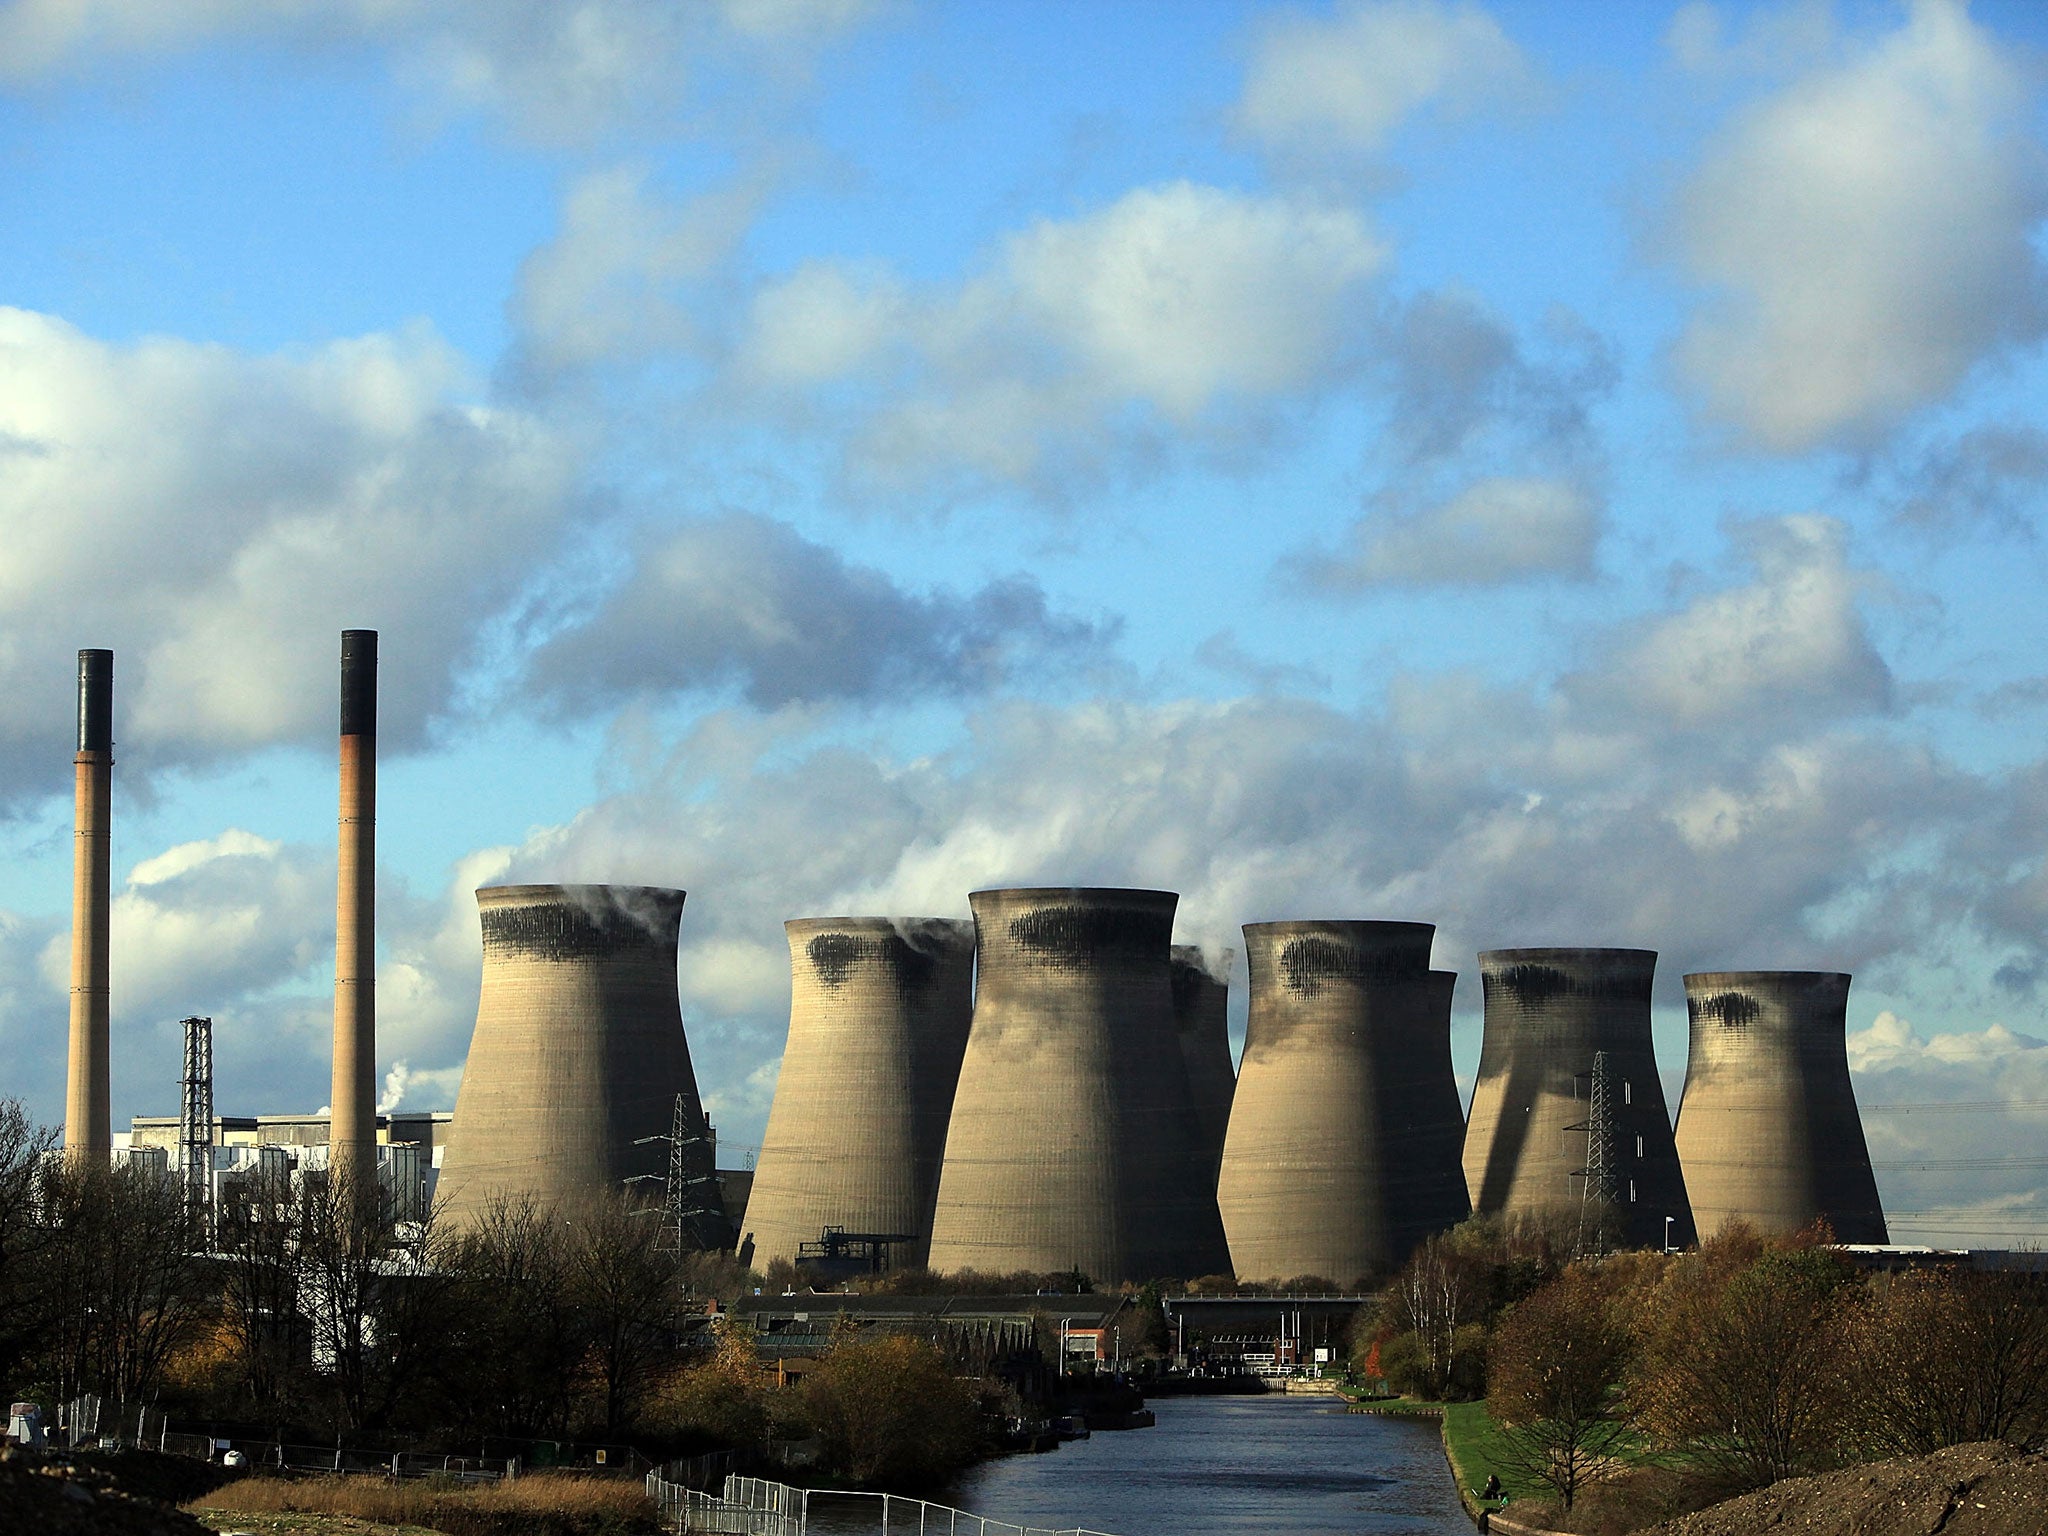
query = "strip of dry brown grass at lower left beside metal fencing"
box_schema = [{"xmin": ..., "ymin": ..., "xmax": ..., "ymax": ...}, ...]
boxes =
[{"xmin": 186, "ymin": 1473, "xmax": 662, "ymax": 1536}]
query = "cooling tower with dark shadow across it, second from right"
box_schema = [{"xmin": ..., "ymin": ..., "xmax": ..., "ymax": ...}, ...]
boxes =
[{"xmin": 1464, "ymin": 950, "xmax": 1694, "ymax": 1247}]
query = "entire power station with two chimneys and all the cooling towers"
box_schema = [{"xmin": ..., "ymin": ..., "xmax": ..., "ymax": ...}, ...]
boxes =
[{"xmin": 36, "ymin": 629, "xmax": 1916, "ymax": 1284}]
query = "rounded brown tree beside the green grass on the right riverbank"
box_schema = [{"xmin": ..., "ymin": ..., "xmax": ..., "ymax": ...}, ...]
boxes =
[{"xmin": 1487, "ymin": 1266, "xmax": 1632, "ymax": 1509}]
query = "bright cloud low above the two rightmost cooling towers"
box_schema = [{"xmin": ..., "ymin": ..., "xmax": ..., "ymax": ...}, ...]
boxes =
[{"xmin": 1583, "ymin": 516, "xmax": 1892, "ymax": 727}]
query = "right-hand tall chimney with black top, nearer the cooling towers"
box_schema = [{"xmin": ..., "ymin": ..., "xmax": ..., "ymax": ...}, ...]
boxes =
[{"xmin": 328, "ymin": 629, "xmax": 377, "ymax": 1196}]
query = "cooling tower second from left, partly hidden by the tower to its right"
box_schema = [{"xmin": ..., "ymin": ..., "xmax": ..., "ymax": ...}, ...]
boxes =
[{"xmin": 741, "ymin": 918, "xmax": 975, "ymax": 1268}]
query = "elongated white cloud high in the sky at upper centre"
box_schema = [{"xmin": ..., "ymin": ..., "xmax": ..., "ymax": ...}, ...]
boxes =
[{"xmin": 735, "ymin": 182, "xmax": 1384, "ymax": 492}]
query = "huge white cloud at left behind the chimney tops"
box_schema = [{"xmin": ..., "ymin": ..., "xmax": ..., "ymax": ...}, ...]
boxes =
[{"xmin": 0, "ymin": 309, "xmax": 580, "ymax": 795}]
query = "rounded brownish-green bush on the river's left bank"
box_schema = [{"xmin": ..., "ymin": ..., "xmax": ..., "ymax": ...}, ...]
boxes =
[{"xmin": 801, "ymin": 1333, "xmax": 983, "ymax": 1489}]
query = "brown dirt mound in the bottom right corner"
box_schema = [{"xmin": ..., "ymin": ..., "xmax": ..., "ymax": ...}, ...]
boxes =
[{"xmin": 1640, "ymin": 1444, "xmax": 2048, "ymax": 1536}]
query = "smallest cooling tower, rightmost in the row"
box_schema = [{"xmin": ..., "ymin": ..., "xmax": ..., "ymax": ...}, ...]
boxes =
[{"xmin": 1677, "ymin": 971, "xmax": 1890, "ymax": 1243}]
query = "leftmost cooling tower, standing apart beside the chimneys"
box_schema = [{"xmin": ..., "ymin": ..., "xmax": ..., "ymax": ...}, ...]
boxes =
[{"xmin": 440, "ymin": 885, "xmax": 713, "ymax": 1221}]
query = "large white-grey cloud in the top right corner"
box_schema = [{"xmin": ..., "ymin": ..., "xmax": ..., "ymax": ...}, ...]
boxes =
[{"xmin": 1675, "ymin": 0, "xmax": 2048, "ymax": 453}]
